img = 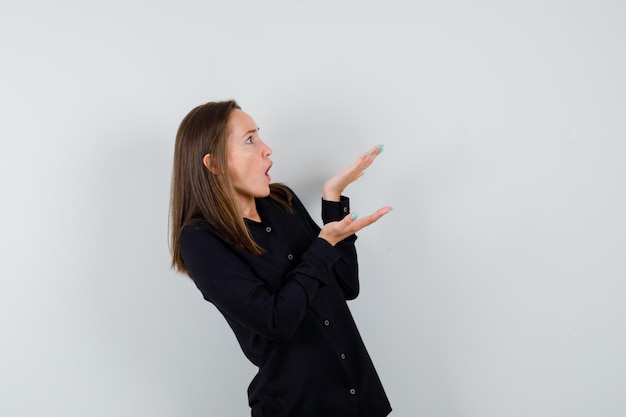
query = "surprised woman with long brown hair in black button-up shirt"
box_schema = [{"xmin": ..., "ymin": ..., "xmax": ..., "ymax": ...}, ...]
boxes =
[{"xmin": 171, "ymin": 101, "xmax": 391, "ymax": 417}]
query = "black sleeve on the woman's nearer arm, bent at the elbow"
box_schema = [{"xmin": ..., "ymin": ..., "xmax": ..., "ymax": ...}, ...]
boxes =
[{"xmin": 180, "ymin": 225, "xmax": 339, "ymax": 342}]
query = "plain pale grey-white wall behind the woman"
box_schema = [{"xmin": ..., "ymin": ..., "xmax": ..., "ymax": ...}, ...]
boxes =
[{"xmin": 0, "ymin": 0, "xmax": 626, "ymax": 417}]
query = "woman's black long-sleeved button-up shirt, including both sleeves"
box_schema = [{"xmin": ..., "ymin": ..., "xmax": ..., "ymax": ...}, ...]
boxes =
[{"xmin": 180, "ymin": 188, "xmax": 391, "ymax": 417}]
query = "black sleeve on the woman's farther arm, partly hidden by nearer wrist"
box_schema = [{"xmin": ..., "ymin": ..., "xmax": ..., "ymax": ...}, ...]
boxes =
[{"xmin": 322, "ymin": 196, "xmax": 360, "ymax": 300}]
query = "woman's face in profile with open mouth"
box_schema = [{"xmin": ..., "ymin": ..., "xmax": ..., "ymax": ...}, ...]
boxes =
[{"xmin": 226, "ymin": 109, "xmax": 272, "ymax": 201}]
